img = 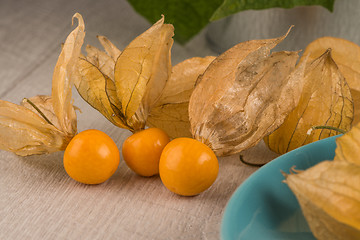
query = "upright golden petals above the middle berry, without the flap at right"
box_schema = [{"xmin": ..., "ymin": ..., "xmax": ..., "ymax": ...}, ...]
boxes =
[{"xmin": 75, "ymin": 17, "xmax": 174, "ymax": 132}]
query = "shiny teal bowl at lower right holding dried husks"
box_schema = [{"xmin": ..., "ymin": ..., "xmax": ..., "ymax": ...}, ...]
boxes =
[{"xmin": 220, "ymin": 136, "xmax": 338, "ymax": 240}]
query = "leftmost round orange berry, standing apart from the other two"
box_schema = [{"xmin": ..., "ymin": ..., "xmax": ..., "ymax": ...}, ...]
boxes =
[{"xmin": 64, "ymin": 129, "xmax": 120, "ymax": 184}]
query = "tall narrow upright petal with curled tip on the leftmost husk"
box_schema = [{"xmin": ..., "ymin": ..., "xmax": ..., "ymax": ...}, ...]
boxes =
[{"xmin": 51, "ymin": 13, "xmax": 85, "ymax": 136}]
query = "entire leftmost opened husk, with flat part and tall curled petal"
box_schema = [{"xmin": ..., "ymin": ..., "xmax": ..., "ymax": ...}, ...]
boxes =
[{"xmin": 0, "ymin": 13, "xmax": 85, "ymax": 156}]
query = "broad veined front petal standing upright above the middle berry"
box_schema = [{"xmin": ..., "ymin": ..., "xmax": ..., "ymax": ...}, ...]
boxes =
[{"xmin": 115, "ymin": 17, "xmax": 174, "ymax": 128}]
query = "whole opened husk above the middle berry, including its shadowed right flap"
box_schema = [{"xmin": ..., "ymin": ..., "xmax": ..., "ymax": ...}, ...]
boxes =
[{"xmin": 75, "ymin": 17, "xmax": 215, "ymax": 138}]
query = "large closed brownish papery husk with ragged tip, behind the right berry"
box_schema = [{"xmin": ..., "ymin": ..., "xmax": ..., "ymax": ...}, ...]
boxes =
[{"xmin": 189, "ymin": 28, "xmax": 305, "ymax": 156}]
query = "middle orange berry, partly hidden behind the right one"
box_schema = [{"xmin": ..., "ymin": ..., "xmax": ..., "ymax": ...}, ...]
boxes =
[{"xmin": 122, "ymin": 128, "xmax": 170, "ymax": 177}]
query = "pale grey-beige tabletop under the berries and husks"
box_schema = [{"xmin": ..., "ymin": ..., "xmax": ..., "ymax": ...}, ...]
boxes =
[{"xmin": 0, "ymin": 0, "xmax": 357, "ymax": 240}]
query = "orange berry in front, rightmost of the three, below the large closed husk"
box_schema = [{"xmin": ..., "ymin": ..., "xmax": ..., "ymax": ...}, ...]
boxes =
[{"xmin": 159, "ymin": 138, "xmax": 219, "ymax": 196}]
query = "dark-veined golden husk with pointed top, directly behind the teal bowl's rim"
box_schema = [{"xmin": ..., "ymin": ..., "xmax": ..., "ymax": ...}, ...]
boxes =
[{"xmin": 264, "ymin": 50, "xmax": 353, "ymax": 154}]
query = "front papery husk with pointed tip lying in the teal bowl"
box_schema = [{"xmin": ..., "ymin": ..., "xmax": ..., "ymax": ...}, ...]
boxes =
[{"xmin": 286, "ymin": 160, "xmax": 360, "ymax": 240}]
